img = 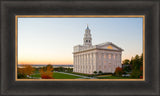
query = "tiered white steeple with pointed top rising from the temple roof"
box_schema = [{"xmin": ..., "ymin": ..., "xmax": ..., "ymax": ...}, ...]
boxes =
[{"xmin": 83, "ymin": 24, "xmax": 92, "ymax": 47}]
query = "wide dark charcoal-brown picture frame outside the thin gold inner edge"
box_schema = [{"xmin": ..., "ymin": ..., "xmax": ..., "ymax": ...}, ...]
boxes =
[{"xmin": 0, "ymin": 0, "xmax": 160, "ymax": 96}]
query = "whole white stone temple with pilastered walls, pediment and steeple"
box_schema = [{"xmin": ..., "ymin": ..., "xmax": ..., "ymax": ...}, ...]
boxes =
[{"xmin": 73, "ymin": 25, "xmax": 123, "ymax": 74}]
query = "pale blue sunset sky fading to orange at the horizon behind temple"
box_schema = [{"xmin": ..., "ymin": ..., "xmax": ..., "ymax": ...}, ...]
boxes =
[{"xmin": 18, "ymin": 17, "xmax": 143, "ymax": 64}]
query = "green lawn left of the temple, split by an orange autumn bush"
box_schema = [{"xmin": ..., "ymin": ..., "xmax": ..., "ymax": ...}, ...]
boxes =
[{"xmin": 31, "ymin": 72, "xmax": 81, "ymax": 79}]
